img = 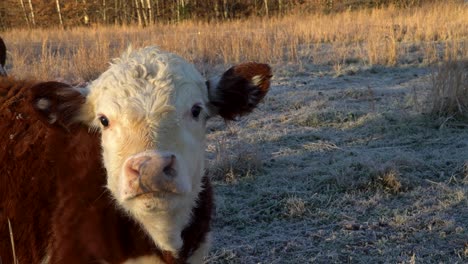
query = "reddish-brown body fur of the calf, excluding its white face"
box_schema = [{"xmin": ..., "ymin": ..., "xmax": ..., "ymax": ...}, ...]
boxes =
[{"xmin": 0, "ymin": 78, "xmax": 213, "ymax": 264}]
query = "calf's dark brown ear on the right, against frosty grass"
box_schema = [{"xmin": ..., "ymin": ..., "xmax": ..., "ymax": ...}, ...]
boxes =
[{"xmin": 206, "ymin": 62, "xmax": 272, "ymax": 120}]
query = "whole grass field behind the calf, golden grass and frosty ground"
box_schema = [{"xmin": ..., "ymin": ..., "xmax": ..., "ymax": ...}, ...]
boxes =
[{"xmin": 2, "ymin": 2, "xmax": 468, "ymax": 263}]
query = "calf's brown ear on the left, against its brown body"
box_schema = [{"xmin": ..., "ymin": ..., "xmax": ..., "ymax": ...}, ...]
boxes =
[{"xmin": 30, "ymin": 82, "xmax": 86, "ymax": 131}]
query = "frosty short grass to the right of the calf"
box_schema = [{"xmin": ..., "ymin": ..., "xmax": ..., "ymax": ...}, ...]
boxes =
[{"xmin": 207, "ymin": 61, "xmax": 468, "ymax": 263}]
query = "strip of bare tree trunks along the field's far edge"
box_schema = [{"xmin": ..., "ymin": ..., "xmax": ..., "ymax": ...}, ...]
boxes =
[{"xmin": 0, "ymin": 0, "xmax": 436, "ymax": 30}]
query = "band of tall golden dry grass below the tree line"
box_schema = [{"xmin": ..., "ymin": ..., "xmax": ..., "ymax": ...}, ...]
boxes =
[{"xmin": 2, "ymin": 1, "xmax": 468, "ymax": 81}]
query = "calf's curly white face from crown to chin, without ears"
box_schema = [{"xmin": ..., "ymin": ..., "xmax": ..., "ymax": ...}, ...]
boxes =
[{"xmin": 85, "ymin": 48, "xmax": 210, "ymax": 215}]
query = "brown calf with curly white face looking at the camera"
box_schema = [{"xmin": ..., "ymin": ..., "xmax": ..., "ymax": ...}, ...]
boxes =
[{"xmin": 0, "ymin": 47, "xmax": 271, "ymax": 263}]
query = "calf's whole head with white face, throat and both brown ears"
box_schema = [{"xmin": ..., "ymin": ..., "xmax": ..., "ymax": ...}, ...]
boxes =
[{"xmin": 32, "ymin": 47, "xmax": 271, "ymax": 254}]
